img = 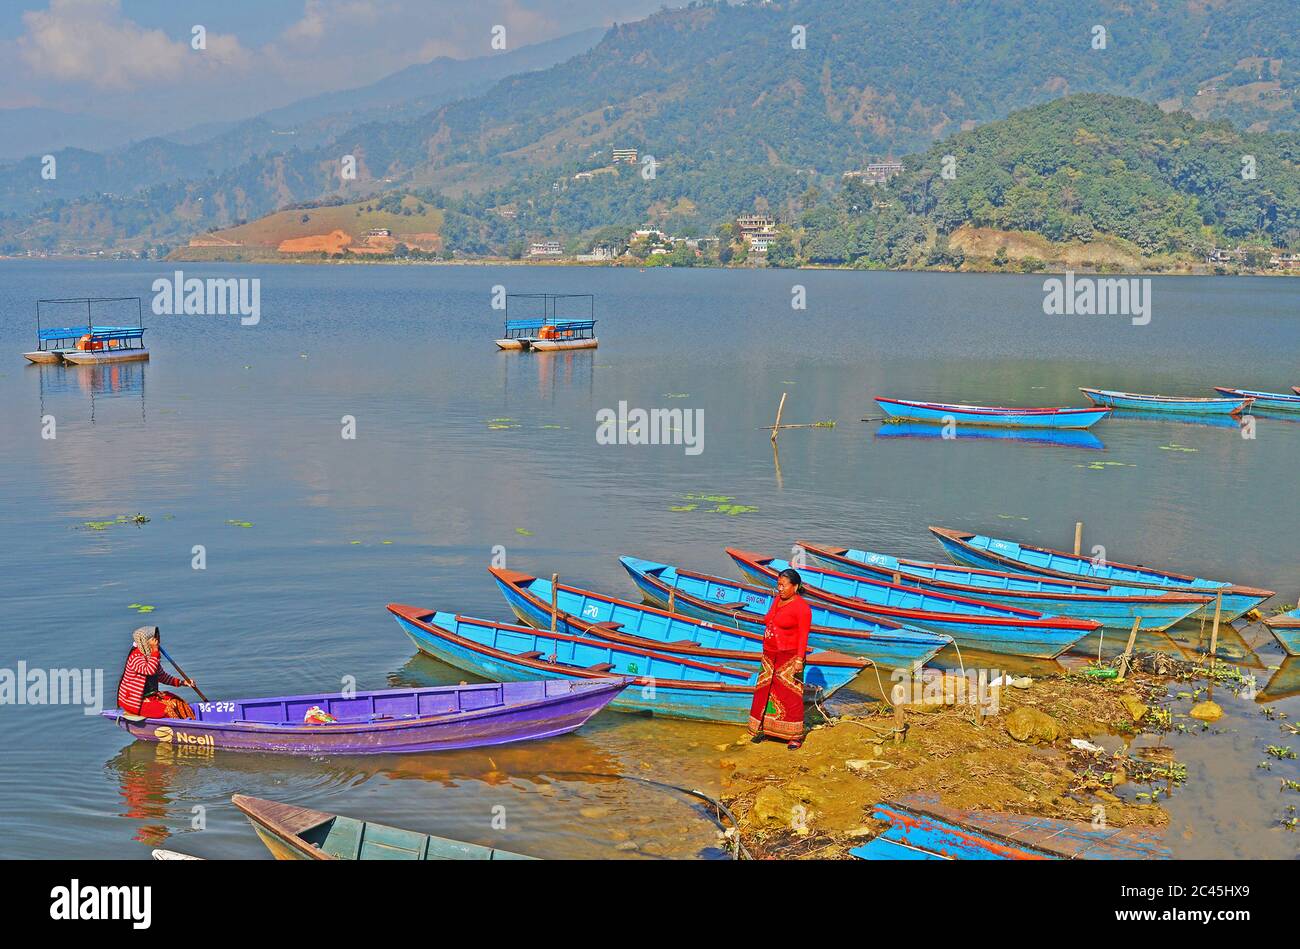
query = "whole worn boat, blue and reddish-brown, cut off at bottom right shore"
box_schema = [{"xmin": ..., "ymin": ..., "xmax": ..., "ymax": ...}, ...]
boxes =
[{"xmin": 850, "ymin": 793, "xmax": 1173, "ymax": 861}]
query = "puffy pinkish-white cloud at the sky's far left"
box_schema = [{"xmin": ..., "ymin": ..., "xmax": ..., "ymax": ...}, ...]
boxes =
[{"xmin": 17, "ymin": 0, "xmax": 247, "ymax": 90}]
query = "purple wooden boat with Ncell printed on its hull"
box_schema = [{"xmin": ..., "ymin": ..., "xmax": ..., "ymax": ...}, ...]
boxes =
[{"xmin": 100, "ymin": 677, "xmax": 632, "ymax": 754}]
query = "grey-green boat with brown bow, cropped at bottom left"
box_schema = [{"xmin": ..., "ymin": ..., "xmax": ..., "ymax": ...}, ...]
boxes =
[{"xmin": 230, "ymin": 794, "xmax": 537, "ymax": 861}]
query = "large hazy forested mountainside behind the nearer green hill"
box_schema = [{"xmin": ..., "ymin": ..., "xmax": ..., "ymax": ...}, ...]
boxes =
[{"xmin": 0, "ymin": 0, "xmax": 1300, "ymax": 253}]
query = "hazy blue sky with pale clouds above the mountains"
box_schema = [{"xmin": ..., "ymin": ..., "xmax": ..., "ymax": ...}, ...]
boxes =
[{"xmin": 0, "ymin": 0, "xmax": 680, "ymax": 129}]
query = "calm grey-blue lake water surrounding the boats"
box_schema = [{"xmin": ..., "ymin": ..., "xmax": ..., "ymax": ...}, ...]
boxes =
[{"xmin": 0, "ymin": 261, "xmax": 1300, "ymax": 858}]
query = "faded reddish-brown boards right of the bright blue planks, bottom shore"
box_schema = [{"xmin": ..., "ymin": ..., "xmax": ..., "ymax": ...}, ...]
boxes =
[{"xmin": 892, "ymin": 794, "xmax": 1173, "ymax": 861}]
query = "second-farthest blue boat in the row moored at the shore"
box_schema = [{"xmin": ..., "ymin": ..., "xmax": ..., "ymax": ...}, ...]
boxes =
[{"xmin": 798, "ymin": 541, "xmax": 1209, "ymax": 631}]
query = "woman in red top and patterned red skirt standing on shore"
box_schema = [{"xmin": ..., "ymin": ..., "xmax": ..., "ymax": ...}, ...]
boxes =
[{"xmin": 749, "ymin": 569, "xmax": 813, "ymax": 751}]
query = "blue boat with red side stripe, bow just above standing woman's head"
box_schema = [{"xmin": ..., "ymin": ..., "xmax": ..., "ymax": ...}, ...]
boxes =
[{"xmin": 727, "ymin": 547, "xmax": 1101, "ymax": 659}]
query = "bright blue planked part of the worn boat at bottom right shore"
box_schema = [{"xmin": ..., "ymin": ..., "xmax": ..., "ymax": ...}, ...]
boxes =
[{"xmin": 849, "ymin": 803, "xmax": 1061, "ymax": 861}]
